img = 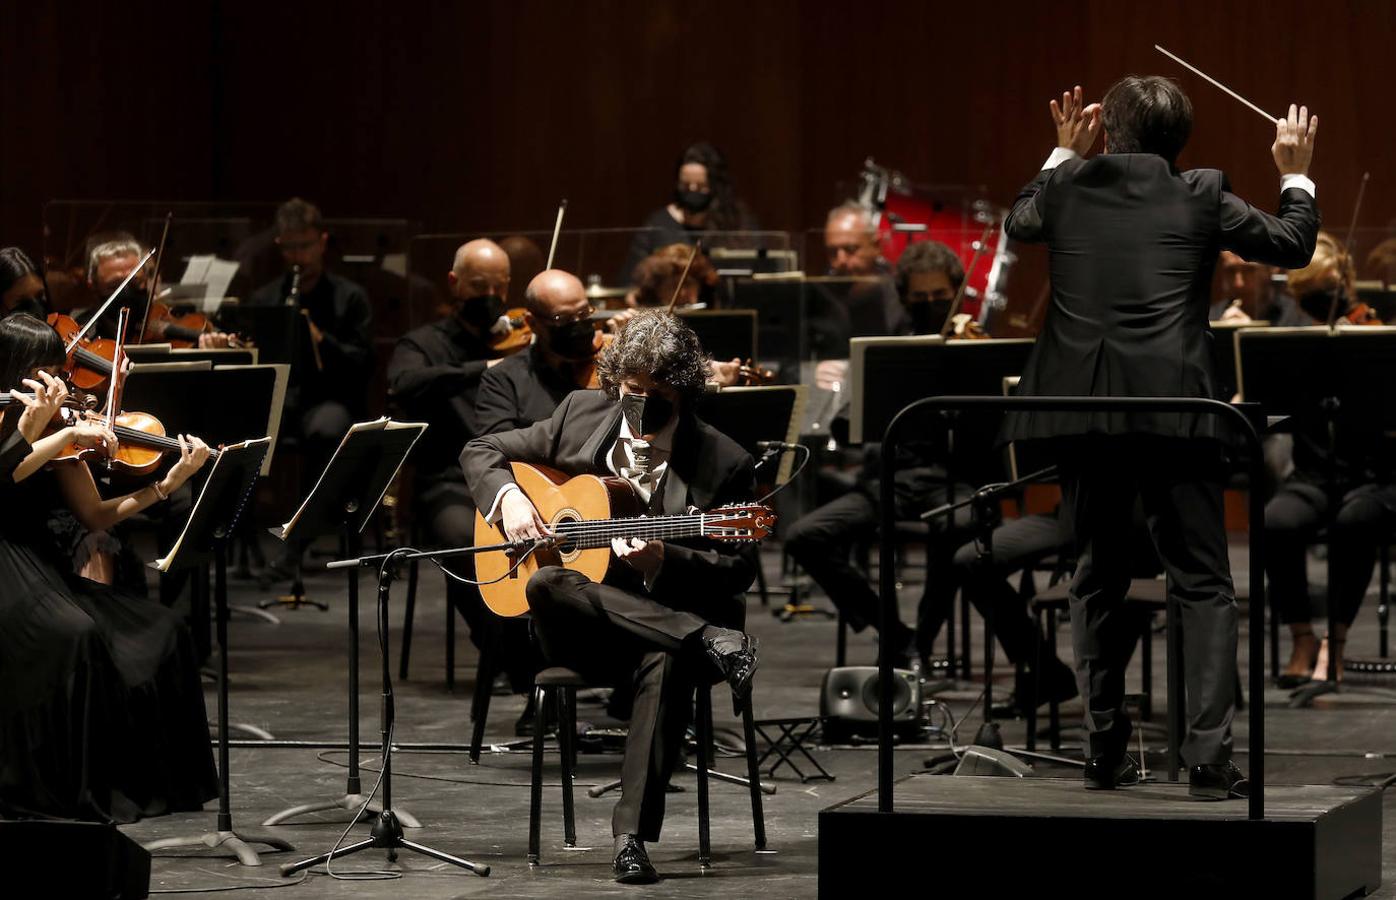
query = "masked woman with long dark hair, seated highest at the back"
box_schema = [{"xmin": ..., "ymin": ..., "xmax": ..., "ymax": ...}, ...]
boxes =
[{"xmin": 617, "ymin": 141, "xmax": 757, "ymax": 283}]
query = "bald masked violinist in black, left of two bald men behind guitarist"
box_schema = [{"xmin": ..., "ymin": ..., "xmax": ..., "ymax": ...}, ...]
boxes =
[{"xmin": 388, "ymin": 239, "xmax": 535, "ymax": 714}]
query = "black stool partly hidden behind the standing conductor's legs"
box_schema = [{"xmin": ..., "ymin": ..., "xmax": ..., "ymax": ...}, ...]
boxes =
[{"xmin": 1025, "ymin": 578, "xmax": 1185, "ymax": 781}]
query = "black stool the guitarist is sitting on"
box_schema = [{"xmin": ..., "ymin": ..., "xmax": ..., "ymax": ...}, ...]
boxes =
[{"xmin": 528, "ymin": 666, "xmax": 766, "ymax": 869}]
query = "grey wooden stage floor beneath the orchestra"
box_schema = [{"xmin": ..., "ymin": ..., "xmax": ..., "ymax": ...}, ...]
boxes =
[{"xmin": 123, "ymin": 535, "xmax": 1396, "ymax": 899}]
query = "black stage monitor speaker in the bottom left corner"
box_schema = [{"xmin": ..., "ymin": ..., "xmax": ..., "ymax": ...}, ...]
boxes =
[{"xmin": 0, "ymin": 820, "xmax": 151, "ymax": 900}]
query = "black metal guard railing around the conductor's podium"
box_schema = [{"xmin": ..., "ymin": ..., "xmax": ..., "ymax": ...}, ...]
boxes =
[{"xmin": 877, "ymin": 396, "xmax": 1265, "ymax": 820}]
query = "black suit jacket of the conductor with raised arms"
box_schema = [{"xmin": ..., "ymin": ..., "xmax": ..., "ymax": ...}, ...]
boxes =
[{"xmin": 1005, "ymin": 153, "xmax": 1319, "ymax": 440}]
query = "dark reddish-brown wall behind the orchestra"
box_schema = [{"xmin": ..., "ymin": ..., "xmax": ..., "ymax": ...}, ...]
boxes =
[{"xmin": 0, "ymin": 0, "xmax": 1396, "ymax": 263}]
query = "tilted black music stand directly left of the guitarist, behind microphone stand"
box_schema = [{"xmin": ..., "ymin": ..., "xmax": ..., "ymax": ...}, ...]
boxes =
[{"xmin": 262, "ymin": 419, "xmax": 427, "ymax": 827}]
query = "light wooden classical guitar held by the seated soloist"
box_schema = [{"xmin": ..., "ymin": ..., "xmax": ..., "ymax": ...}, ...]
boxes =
[{"xmin": 475, "ymin": 462, "xmax": 776, "ymax": 615}]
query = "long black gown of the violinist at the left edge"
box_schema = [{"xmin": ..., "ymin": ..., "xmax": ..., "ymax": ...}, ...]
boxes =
[{"xmin": 0, "ymin": 430, "xmax": 218, "ymax": 822}]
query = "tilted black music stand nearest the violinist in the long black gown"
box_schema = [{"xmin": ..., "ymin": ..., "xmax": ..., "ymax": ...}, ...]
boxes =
[{"xmin": 145, "ymin": 438, "xmax": 295, "ymax": 865}]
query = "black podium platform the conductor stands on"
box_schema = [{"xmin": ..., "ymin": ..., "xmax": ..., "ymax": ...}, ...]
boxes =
[{"xmin": 819, "ymin": 776, "xmax": 1382, "ymax": 900}]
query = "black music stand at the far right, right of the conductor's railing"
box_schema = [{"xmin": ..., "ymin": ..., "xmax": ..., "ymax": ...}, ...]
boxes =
[{"xmin": 1235, "ymin": 325, "xmax": 1396, "ymax": 697}]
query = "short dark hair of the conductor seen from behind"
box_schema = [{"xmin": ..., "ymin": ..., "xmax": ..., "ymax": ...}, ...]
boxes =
[{"xmin": 1100, "ymin": 75, "xmax": 1192, "ymax": 165}]
